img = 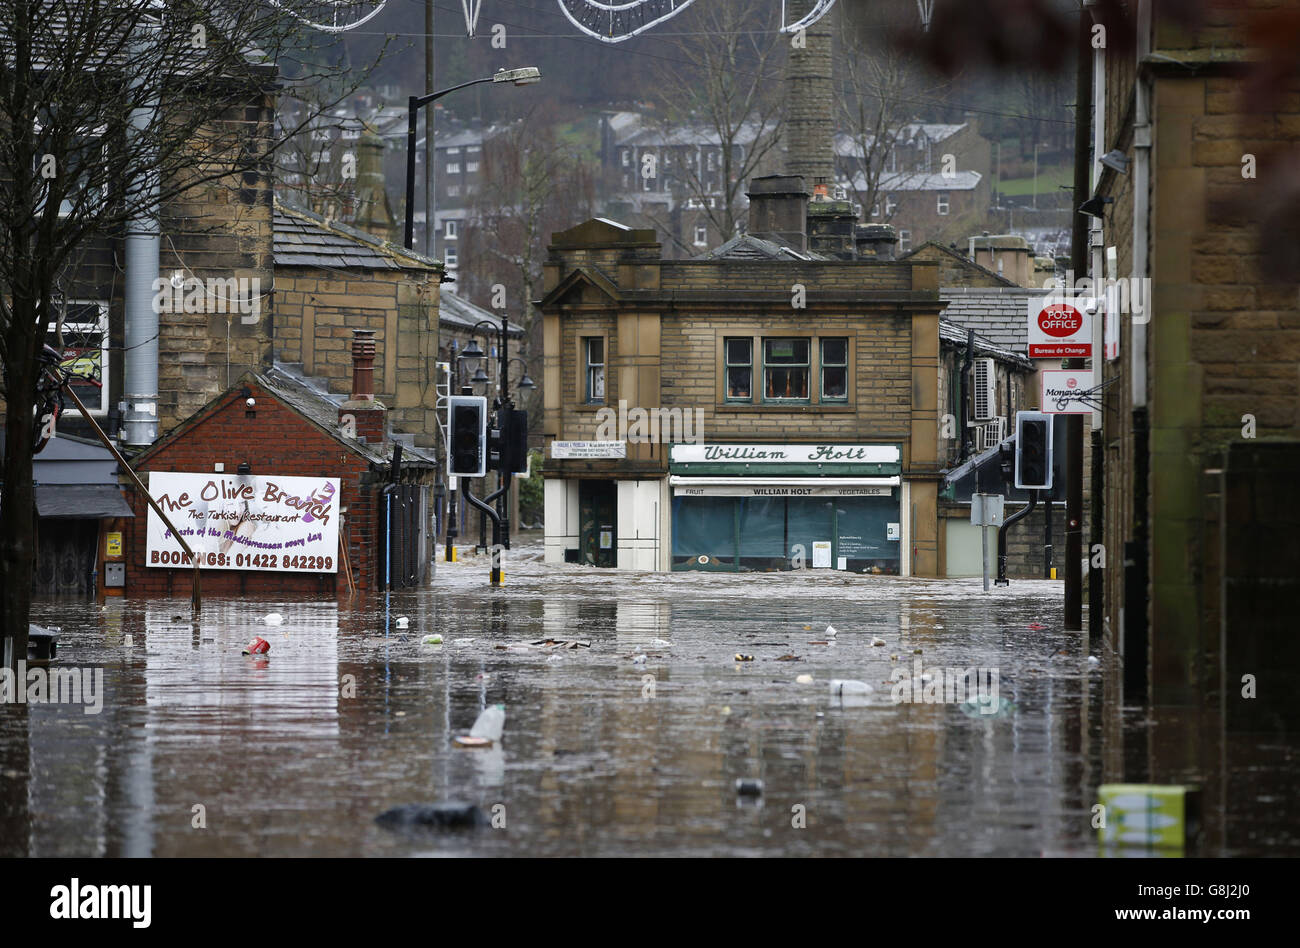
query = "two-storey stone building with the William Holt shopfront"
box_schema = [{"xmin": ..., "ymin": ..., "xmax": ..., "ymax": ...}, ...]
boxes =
[{"xmin": 541, "ymin": 176, "xmax": 941, "ymax": 576}]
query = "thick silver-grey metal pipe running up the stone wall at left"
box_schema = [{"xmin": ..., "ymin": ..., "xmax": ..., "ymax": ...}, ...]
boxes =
[{"xmin": 122, "ymin": 20, "xmax": 163, "ymax": 446}]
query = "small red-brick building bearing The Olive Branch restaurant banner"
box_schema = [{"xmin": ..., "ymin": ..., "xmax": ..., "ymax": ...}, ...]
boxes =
[{"xmin": 122, "ymin": 330, "xmax": 437, "ymax": 597}]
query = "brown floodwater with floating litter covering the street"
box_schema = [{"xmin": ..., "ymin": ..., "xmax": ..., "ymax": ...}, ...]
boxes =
[{"xmin": 0, "ymin": 544, "xmax": 1296, "ymax": 856}]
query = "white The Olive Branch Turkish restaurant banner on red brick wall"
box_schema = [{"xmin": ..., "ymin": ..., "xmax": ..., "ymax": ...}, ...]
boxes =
[{"xmin": 146, "ymin": 471, "xmax": 339, "ymax": 572}]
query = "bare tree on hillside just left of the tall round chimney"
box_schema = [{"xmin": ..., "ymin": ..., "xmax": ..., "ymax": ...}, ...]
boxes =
[{"xmin": 647, "ymin": 3, "xmax": 785, "ymax": 241}]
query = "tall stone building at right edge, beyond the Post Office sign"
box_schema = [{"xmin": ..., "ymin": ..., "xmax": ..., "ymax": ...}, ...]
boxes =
[{"xmin": 1091, "ymin": 0, "xmax": 1300, "ymax": 733}]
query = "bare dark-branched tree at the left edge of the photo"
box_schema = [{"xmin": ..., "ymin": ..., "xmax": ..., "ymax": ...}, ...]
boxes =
[{"xmin": 0, "ymin": 0, "xmax": 379, "ymax": 662}]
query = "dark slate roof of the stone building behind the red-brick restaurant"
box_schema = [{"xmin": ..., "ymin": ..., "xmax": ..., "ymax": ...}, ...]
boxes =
[{"xmin": 272, "ymin": 199, "xmax": 442, "ymax": 270}]
